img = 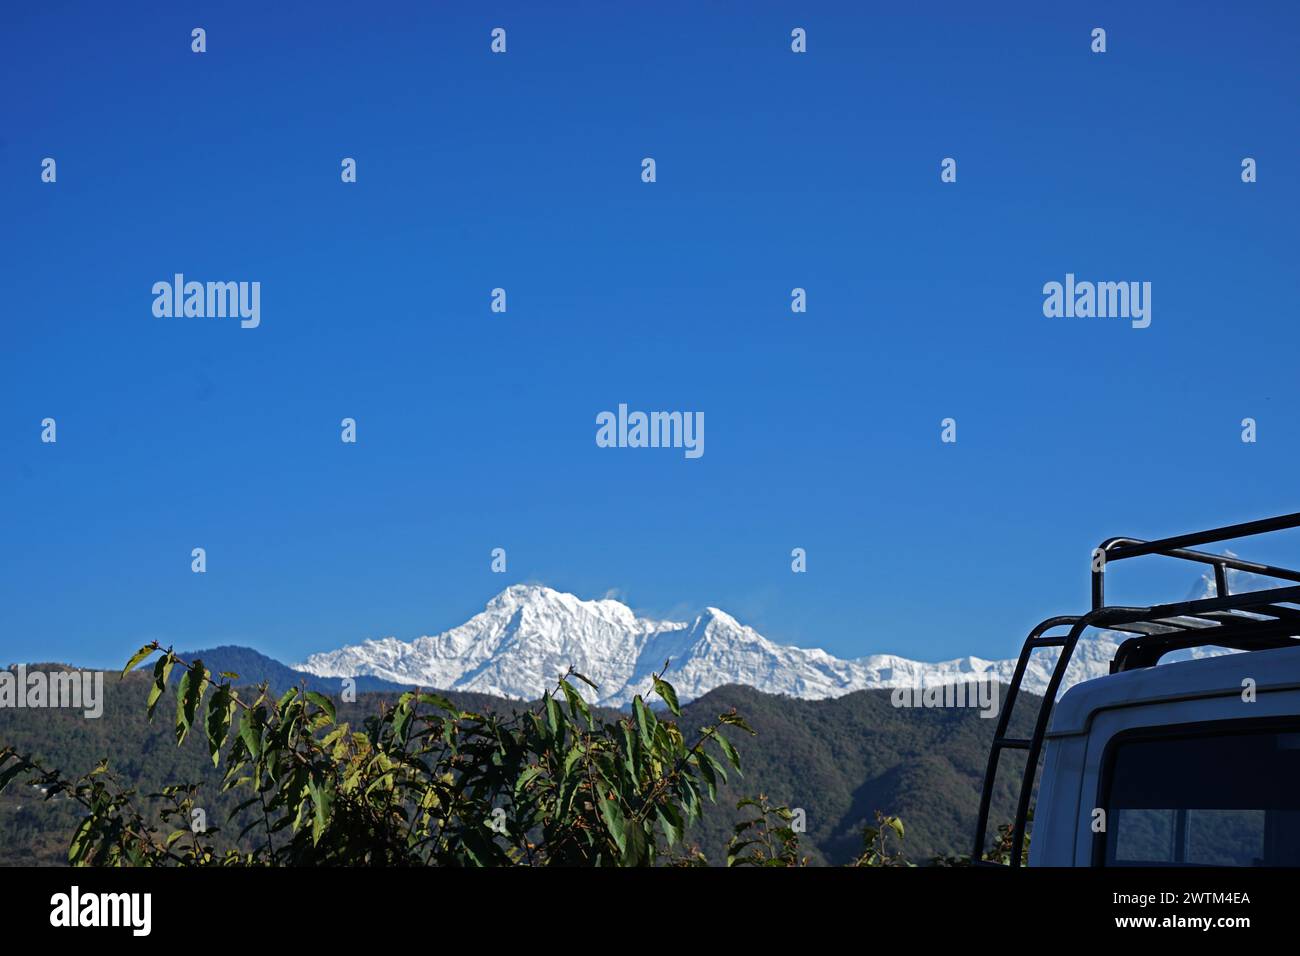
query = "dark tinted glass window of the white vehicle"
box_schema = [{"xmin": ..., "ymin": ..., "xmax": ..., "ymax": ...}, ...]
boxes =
[{"xmin": 1105, "ymin": 728, "xmax": 1300, "ymax": 866}]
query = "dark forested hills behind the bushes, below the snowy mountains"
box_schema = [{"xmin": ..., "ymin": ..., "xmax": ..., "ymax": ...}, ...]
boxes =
[{"xmin": 0, "ymin": 659, "xmax": 1030, "ymax": 865}]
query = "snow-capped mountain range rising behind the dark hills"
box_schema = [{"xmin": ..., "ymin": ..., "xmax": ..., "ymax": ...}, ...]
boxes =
[{"xmin": 295, "ymin": 584, "xmax": 1237, "ymax": 706}]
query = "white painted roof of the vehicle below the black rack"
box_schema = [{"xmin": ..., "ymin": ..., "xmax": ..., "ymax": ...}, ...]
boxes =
[{"xmin": 1048, "ymin": 648, "xmax": 1300, "ymax": 736}]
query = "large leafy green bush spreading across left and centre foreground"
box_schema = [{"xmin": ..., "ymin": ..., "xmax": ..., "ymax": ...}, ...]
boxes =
[{"xmin": 0, "ymin": 643, "xmax": 753, "ymax": 866}]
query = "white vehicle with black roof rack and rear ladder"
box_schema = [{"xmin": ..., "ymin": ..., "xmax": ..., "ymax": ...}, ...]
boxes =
[{"xmin": 972, "ymin": 514, "xmax": 1300, "ymax": 866}]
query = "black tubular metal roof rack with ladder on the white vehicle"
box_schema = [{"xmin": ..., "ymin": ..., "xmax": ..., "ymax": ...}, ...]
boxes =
[{"xmin": 971, "ymin": 512, "xmax": 1300, "ymax": 866}]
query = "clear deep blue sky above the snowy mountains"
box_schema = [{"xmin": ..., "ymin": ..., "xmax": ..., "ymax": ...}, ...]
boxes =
[{"xmin": 0, "ymin": 0, "xmax": 1300, "ymax": 665}]
